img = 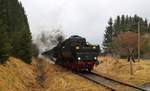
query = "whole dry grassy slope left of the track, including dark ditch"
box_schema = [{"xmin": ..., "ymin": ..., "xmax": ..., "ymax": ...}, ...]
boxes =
[{"xmin": 0, "ymin": 57, "xmax": 108, "ymax": 91}]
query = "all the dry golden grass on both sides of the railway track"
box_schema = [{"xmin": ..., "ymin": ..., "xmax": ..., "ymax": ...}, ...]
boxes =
[{"xmin": 0, "ymin": 57, "xmax": 150, "ymax": 91}]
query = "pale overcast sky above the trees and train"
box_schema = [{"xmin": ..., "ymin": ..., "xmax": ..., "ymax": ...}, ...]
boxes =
[{"xmin": 21, "ymin": 0, "xmax": 150, "ymax": 44}]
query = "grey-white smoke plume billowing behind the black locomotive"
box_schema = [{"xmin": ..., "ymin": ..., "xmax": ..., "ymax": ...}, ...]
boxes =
[{"xmin": 34, "ymin": 29, "xmax": 65, "ymax": 54}]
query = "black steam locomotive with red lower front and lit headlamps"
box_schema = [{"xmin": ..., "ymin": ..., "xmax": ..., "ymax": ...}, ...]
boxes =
[{"xmin": 42, "ymin": 35, "xmax": 100, "ymax": 71}]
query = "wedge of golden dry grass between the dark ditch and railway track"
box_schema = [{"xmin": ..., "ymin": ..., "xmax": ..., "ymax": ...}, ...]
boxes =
[{"xmin": 40, "ymin": 60, "xmax": 109, "ymax": 91}]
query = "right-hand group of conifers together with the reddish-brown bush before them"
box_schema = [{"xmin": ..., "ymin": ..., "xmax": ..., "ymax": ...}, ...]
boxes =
[{"xmin": 103, "ymin": 15, "xmax": 150, "ymax": 56}]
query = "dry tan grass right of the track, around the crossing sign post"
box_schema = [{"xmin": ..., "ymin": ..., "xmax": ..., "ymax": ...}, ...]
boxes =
[{"xmin": 94, "ymin": 57, "xmax": 150, "ymax": 86}]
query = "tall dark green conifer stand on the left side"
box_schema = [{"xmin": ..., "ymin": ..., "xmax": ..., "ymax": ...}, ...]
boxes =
[{"xmin": 0, "ymin": 0, "xmax": 38, "ymax": 64}]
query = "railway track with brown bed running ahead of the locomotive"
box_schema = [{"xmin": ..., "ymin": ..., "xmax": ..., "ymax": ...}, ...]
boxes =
[{"xmin": 77, "ymin": 72, "xmax": 147, "ymax": 91}]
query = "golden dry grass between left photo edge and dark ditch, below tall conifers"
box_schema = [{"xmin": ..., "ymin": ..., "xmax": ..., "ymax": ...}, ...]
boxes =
[{"xmin": 0, "ymin": 57, "xmax": 35, "ymax": 91}]
